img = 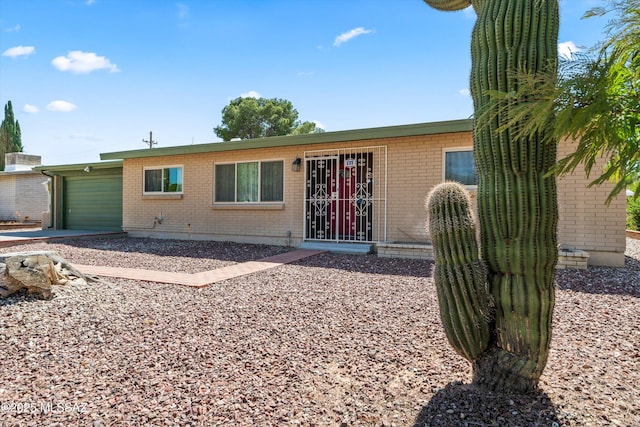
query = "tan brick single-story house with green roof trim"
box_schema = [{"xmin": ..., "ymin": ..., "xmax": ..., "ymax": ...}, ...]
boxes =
[{"xmin": 101, "ymin": 120, "xmax": 625, "ymax": 265}]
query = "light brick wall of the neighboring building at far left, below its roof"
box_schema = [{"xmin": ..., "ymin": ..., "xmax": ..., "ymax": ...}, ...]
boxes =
[{"xmin": 0, "ymin": 172, "xmax": 49, "ymax": 221}]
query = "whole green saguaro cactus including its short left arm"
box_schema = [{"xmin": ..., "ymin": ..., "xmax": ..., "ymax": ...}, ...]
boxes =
[{"xmin": 425, "ymin": 0, "xmax": 559, "ymax": 392}]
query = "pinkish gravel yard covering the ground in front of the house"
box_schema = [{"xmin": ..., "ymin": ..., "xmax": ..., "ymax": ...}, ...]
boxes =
[{"xmin": 0, "ymin": 238, "xmax": 640, "ymax": 427}]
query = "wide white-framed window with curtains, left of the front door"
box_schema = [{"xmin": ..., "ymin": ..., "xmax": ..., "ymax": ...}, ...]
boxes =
[{"xmin": 213, "ymin": 160, "xmax": 284, "ymax": 203}]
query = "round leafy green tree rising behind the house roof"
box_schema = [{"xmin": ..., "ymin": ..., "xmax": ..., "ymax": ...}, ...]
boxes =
[{"xmin": 213, "ymin": 97, "xmax": 322, "ymax": 141}]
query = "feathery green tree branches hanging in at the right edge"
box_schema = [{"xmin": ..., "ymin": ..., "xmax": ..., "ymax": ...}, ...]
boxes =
[{"xmin": 490, "ymin": 0, "xmax": 640, "ymax": 203}]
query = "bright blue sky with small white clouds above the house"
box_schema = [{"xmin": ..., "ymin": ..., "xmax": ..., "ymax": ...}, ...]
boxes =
[{"xmin": 0, "ymin": 0, "xmax": 603, "ymax": 165}]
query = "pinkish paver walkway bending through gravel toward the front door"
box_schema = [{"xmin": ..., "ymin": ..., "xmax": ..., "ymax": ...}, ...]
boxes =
[{"xmin": 74, "ymin": 249, "xmax": 324, "ymax": 288}]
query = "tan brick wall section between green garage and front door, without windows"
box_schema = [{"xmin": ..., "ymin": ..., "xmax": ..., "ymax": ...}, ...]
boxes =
[{"xmin": 123, "ymin": 148, "xmax": 304, "ymax": 245}]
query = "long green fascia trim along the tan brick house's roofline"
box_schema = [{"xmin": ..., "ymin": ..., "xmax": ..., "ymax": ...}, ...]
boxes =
[{"xmin": 100, "ymin": 119, "xmax": 473, "ymax": 160}]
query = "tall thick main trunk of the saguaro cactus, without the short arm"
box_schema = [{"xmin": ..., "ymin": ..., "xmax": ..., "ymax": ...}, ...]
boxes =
[{"xmin": 424, "ymin": 0, "xmax": 559, "ymax": 391}]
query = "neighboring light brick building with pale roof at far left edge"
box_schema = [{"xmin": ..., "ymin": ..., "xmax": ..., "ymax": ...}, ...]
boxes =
[{"xmin": 0, "ymin": 153, "xmax": 49, "ymax": 222}]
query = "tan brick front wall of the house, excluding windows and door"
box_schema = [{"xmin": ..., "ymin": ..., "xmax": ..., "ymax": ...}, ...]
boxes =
[{"xmin": 123, "ymin": 132, "xmax": 625, "ymax": 264}]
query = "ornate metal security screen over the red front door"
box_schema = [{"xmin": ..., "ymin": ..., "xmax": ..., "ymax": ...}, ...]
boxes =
[{"xmin": 305, "ymin": 150, "xmax": 386, "ymax": 242}]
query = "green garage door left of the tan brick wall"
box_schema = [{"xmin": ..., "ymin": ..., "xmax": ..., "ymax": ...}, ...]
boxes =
[{"xmin": 63, "ymin": 175, "xmax": 122, "ymax": 231}]
